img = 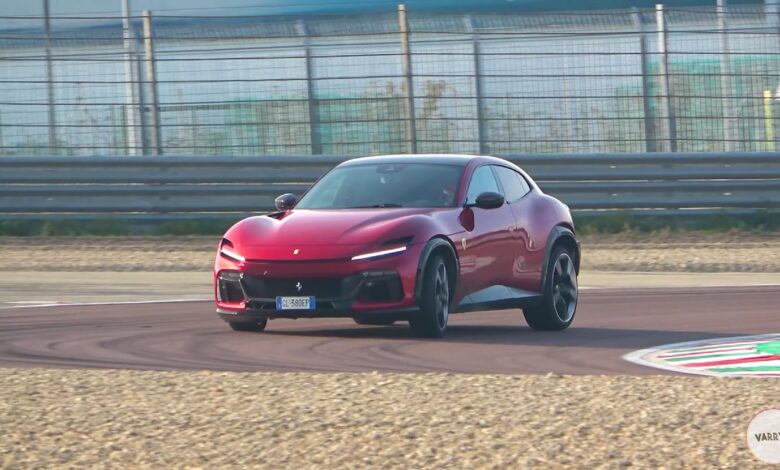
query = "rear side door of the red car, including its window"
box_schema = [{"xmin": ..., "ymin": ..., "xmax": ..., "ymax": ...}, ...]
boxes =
[{"xmin": 493, "ymin": 165, "xmax": 539, "ymax": 291}]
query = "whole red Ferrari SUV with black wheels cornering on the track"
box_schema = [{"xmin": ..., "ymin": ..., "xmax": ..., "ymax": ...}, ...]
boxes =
[{"xmin": 214, "ymin": 155, "xmax": 580, "ymax": 337}]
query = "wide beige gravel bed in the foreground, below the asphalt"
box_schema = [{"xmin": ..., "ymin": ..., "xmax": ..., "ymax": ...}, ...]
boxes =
[{"xmin": 0, "ymin": 369, "xmax": 777, "ymax": 469}]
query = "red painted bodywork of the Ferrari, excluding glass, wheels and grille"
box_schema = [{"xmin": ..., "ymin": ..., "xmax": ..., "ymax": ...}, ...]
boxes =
[{"xmin": 214, "ymin": 155, "xmax": 574, "ymax": 317}]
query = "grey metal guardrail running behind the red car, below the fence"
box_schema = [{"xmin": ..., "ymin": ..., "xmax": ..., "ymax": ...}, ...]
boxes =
[{"xmin": 0, "ymin": 153, "xmax": 780, "ymax": 219}]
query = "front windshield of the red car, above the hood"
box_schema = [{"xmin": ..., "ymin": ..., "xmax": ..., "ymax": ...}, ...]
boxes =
[{"xmin": 295, "ymin": 163, "xmax": 463, "ymax": 209}]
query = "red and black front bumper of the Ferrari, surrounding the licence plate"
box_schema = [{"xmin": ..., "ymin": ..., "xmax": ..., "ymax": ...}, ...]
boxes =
[{"xmin": 214, "ymin": 245, "xmax": 422, "ymax": 320}]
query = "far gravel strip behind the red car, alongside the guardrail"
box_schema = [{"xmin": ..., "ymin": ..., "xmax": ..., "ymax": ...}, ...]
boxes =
[{"xmin": 0, "ymin": 232, "xmax": 780, "ymax": 272}]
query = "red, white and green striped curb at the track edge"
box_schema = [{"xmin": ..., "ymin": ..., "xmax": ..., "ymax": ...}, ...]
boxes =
[{"xmin": 623, "ymin": 333, "xmax": 780, "ymax": 377}]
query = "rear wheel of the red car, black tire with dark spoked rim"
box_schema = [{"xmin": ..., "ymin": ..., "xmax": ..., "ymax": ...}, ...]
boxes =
[{"xmin": 523, "ymin": 247, "xmax": 577, "ymax": 331}]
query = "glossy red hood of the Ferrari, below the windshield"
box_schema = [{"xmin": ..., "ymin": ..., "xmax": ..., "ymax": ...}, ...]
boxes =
[{"xmin": 225, "ymin": 208, "xmax": 444, "ymax": 261}]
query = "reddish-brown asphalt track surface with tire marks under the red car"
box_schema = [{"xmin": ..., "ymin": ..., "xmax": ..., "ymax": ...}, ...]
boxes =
[{"xmin": 0, "ymin": 286, "xmax": 780, "ymax": 375}]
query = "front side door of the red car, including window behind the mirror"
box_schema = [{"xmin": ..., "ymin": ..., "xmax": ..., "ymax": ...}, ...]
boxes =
[{"xmin": 458, "ymin": 165, "xmax": 515, "ymax": 302}]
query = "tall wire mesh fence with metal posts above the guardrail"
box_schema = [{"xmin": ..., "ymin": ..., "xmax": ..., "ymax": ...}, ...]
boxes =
[{"xmin": 0, "ymin": 6, "xmax": 780, "ymax": 155}]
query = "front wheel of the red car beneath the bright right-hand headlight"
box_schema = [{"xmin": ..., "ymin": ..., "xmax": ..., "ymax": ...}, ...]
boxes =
[{"xmin": 409, "ymin": 255, "xmax": 451, "ymax": 338}]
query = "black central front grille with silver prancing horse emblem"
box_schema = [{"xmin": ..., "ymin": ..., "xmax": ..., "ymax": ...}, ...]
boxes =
[{"xmin": 243, "ymin": 276, "xmax": 343, "ymax": 299}]
